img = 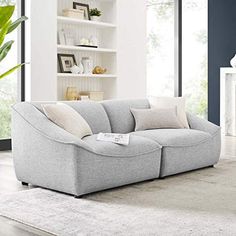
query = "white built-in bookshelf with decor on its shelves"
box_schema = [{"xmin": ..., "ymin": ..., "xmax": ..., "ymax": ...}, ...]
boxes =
[{"xmin": 57, "ymin": 0, "xmax": 117, "ymax": 100}]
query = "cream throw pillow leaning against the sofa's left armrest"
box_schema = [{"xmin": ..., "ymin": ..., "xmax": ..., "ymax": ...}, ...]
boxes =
[{"xmin": 42, "ymin": 103, "xmax": 92, "ymax": 139}]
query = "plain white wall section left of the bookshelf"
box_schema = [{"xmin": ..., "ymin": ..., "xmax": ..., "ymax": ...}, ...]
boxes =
[{"xmin": 26, "ymin": 0, "xmax": 57, "ymax": 101}]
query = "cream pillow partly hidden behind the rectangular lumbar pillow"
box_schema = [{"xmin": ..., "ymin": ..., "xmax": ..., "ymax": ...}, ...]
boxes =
[{"xmin": 149, "ymin": 97, "xmax": 189, "ymax": 129}]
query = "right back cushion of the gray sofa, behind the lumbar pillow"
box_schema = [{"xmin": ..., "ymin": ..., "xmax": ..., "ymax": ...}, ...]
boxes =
[{"xmin": 101, "ymin": 99, "xmax": 150, "ymax": 133}]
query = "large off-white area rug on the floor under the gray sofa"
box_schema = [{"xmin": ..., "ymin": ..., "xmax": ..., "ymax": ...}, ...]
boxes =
[{"xmin": 0, "ymin": 160, "xmax": 236, "ymax": 236}]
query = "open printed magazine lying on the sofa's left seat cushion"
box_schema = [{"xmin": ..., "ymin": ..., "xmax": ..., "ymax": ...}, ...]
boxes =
[{"xmin": 97, "ymin": 133, "xmax": 129, "ymax": 145}]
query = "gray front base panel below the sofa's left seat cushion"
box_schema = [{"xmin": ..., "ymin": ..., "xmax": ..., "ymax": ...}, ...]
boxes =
[{"xmin": 75, "ymin": 148, "xmax": 161, "ymax": 195}]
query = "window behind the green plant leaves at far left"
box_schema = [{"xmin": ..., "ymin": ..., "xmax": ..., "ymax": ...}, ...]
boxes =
[{"xmin": 0, "ymin": 1, "xmax": 23, "ymax": 150}]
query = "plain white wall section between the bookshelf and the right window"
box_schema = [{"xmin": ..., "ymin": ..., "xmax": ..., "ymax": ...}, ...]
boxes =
[{"xmin": 117, "ymin": 0, "xmax": 146, "ymax": 98}]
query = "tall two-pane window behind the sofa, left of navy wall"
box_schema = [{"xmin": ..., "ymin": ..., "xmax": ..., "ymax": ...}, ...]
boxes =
[{"xmin": 147, "ymin": 0, "xmax": 208, "ymax": 118}]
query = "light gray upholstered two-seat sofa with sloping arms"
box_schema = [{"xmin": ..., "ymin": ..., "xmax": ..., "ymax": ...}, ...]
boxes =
[{"xmin": 12, "ymin": 99, "xmax": 221, "ymax": 196}]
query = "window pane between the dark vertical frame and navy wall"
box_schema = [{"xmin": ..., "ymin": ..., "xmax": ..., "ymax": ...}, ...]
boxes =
[{"xmin": 182, "ymin": 0, "xmax": 207, "ymax": 118}]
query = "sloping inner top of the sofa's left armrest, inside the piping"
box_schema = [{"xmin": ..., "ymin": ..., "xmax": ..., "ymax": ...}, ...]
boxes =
[{"xmin": 12, "ymin": 102, "xmax": 91, "ymax": 151}]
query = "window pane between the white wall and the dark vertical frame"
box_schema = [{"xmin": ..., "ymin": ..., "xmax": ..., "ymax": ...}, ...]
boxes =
[{"xmin": 147, "ymin": 0, "xmax": 175, "ymax": 96}]
